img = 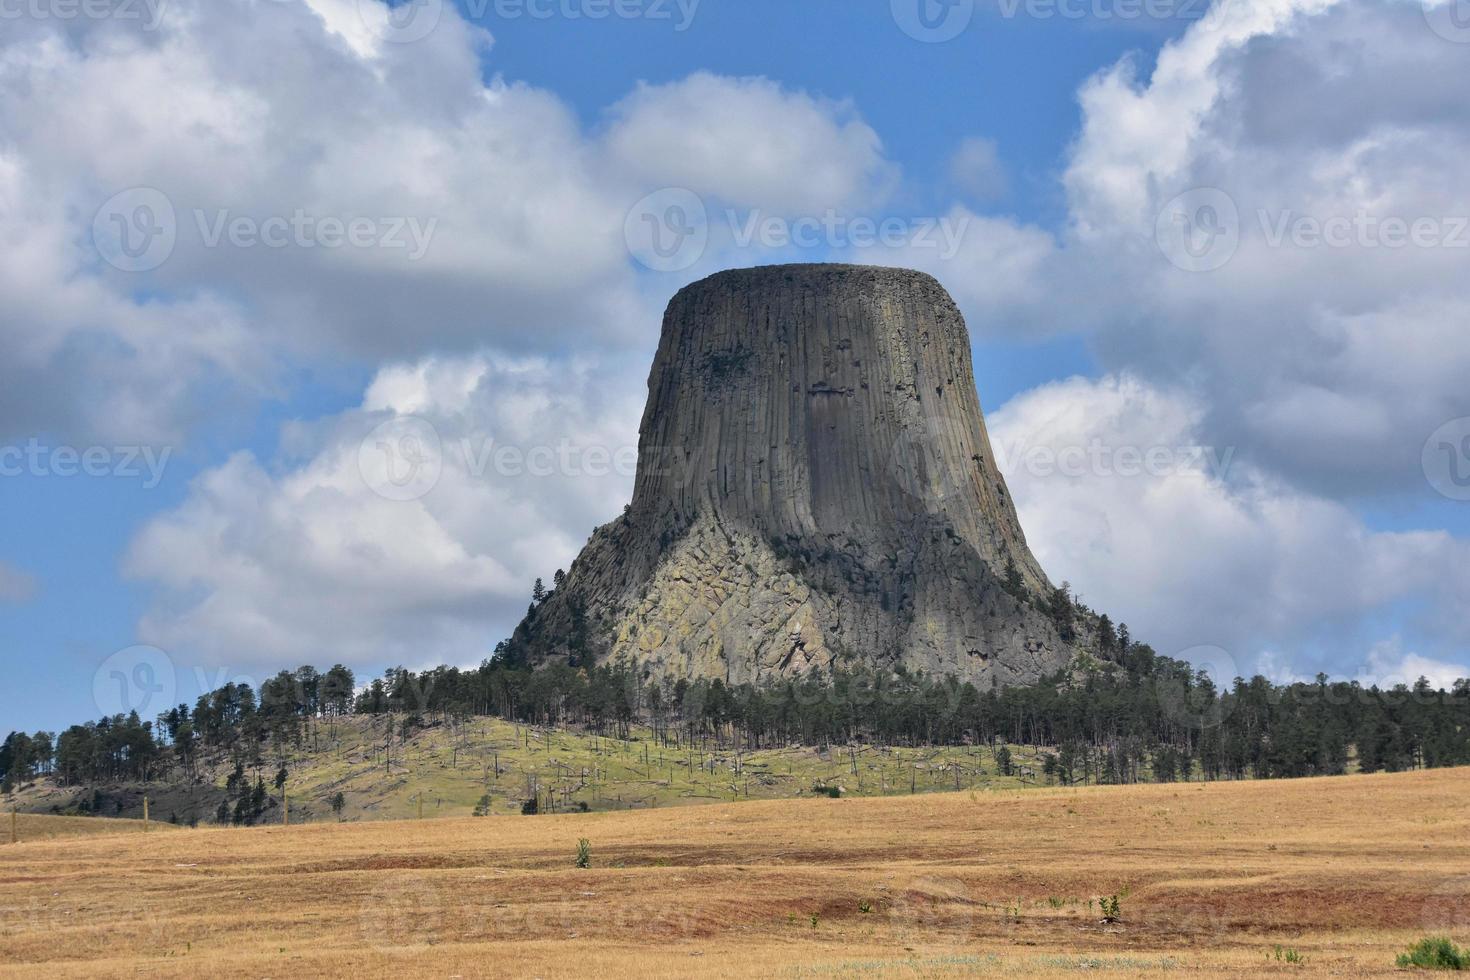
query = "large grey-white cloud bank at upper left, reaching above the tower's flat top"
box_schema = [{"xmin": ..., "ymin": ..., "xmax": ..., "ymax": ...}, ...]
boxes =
[{"xmin": 0, "ymin": 0, "xmax": 892, "ymax": 441}]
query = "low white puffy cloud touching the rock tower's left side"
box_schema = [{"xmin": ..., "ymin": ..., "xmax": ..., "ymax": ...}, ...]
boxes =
[{"xmin": 126, "ymin": 354, "xmax": 642, "ymax": 667}]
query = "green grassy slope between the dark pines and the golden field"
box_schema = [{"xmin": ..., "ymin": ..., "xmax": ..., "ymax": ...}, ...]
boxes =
[{"xmin": 4, "ymin": 716, "xmax": 1058, "ymax": 824}]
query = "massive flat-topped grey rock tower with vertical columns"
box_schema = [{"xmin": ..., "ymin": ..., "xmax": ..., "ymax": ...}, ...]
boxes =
[{"xmin": 510, "ymin": 266, "xmax": 1086, "ymax": 685}]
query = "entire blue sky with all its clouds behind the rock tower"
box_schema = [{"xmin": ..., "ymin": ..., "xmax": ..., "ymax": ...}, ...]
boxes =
[{"xmin": 0, "ymin": 0, "xmax": 1470, "ymax": 729}]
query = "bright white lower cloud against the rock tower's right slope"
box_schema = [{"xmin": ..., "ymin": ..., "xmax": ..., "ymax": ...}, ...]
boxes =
[{"xmin": 989, "ymin": 376, "xmax": 1470, "ymax": 673}]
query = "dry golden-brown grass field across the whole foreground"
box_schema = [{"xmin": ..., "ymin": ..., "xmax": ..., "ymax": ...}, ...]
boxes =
[{"xmin": 0, "ymin": 770, "xmax": 1470, "ymax": 980}]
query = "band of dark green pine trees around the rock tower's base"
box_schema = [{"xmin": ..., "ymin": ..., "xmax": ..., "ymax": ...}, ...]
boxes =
[{"xmin": 0, "ymin": 640, "xmax": 1470, "ymax": 793}]
